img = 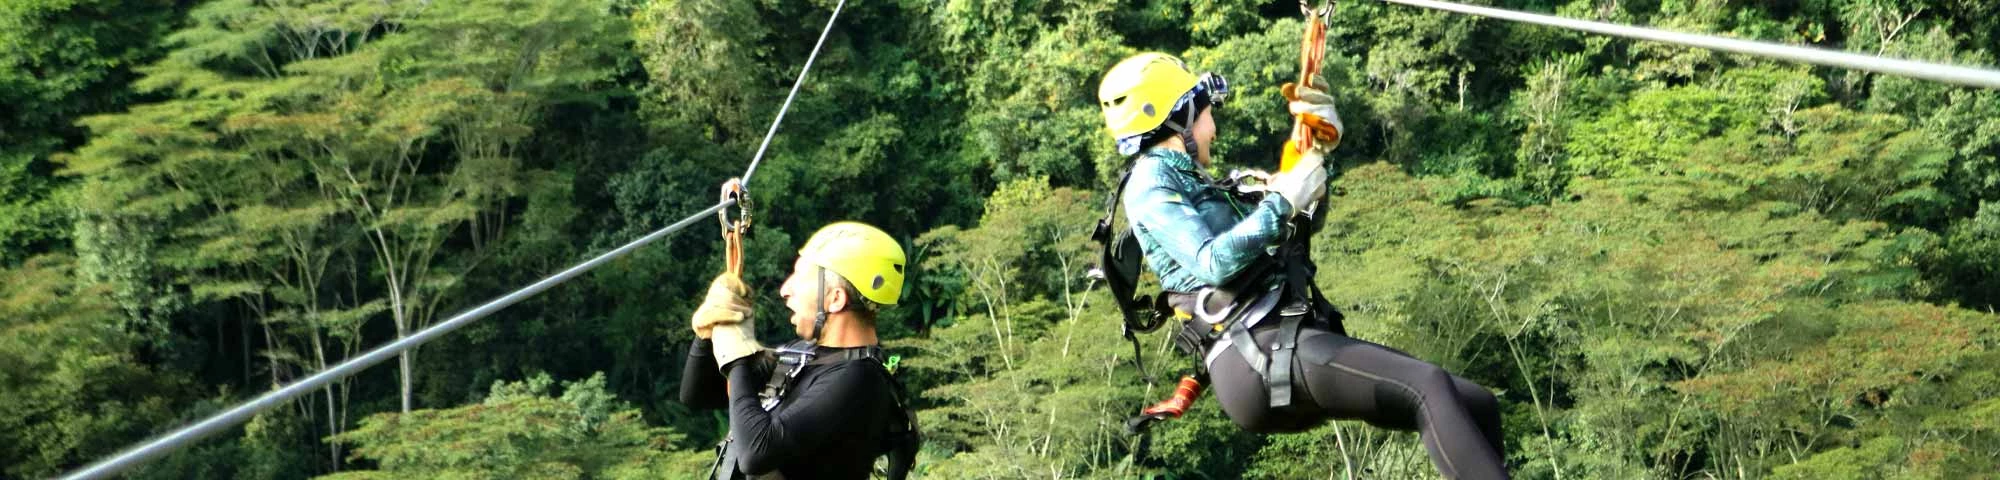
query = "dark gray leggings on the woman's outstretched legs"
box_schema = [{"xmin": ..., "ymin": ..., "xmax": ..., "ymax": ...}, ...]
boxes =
[{"xmin": 1208, "ymin": 322, "xmax": 1508, "ymax": 478}]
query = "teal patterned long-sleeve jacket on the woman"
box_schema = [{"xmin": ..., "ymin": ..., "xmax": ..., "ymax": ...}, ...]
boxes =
[{"xmin": 1122, "ymin": 148, "xmax": 1292, "ymax": 292}]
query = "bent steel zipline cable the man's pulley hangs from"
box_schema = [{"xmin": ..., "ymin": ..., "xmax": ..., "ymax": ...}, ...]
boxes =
[{"xmin": 62, "ymin": 0, "xmax": 848, "ymax": 480}]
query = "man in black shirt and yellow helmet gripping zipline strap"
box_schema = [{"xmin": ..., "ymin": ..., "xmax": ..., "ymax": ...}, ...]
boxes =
[{"xmin": 680, "ymin": 222, "xmax": 916, "ymax": 478}]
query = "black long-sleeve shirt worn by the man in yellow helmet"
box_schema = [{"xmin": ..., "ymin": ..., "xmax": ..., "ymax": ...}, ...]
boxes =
[{"xmin": 680, "ymin": 340, "xmax": 896, "ymax": 478}]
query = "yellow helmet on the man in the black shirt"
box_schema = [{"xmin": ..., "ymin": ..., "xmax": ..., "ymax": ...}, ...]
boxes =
[{"xmin": 798, "ymin": 222, "xmax": 906, "ymax": 306}]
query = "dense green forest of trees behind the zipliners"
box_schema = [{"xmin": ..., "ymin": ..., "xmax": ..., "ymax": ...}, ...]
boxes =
[{"xmin": 0, "ymin": 0, "xmax": 2000, "ymax": 480}]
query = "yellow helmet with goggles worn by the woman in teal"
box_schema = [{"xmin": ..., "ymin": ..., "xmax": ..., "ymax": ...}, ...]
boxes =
[{"xmin": 1098, "ymin": 52, "xmax": 1228, "ymax": 154}]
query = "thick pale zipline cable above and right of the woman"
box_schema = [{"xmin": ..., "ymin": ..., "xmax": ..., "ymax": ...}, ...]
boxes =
[{"xmin": 1382, "ymin": 0, "xmax": 2000, "ymax": 88}]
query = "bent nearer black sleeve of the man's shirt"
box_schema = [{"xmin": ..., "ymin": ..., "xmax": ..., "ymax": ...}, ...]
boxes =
[{"xmin": 728, "ymin": 362, "xmax": 886, "ymax": 474}]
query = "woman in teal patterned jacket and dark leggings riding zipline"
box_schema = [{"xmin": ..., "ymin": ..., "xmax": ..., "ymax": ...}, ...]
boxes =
[{"xmin": 1098, "ymin": 54, "xmax": 1508, "ymax": 478}]
